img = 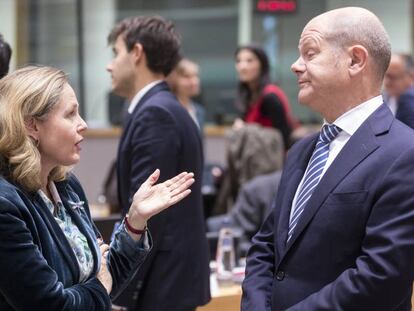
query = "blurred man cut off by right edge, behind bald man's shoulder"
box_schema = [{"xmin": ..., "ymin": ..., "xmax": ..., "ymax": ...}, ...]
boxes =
[{"xmin": 384, "ymin": 54, "xmax": 414, "ymax": 128}]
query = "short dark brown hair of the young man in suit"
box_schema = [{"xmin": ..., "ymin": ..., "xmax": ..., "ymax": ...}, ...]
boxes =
[{"xmin": 108, "ymin": 16, "xmax": 181, "ymax": 76}]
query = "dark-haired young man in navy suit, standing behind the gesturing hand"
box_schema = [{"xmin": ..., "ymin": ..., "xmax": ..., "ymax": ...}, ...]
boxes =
[{"xmin": 107, "ymin": 17, "xmax": 210, "ymax": 311}]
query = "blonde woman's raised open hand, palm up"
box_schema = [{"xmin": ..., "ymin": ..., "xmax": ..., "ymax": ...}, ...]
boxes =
[{"xmin": 128, "ymin": 169, "xmax": 194, "ymax": 229}]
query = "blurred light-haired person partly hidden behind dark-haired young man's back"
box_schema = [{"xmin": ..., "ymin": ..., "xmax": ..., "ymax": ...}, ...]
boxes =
[{"xmin": 167, "ymin": 58, "xmax": 205, "ymax": 133}]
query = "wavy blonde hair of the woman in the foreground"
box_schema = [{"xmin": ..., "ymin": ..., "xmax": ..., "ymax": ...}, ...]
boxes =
[{"xmin": 0, "ymin": 66, "xmax": 69, "ymax": 191}]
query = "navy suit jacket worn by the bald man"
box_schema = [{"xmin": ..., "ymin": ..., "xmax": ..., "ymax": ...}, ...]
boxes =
[{"xmin": 242, "ymin": 105, "xmax": 414, "ymax": 311}]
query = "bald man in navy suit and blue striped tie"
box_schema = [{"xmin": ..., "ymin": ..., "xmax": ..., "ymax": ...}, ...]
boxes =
[{"xmin": 242, "ymin": 8, "xmax": 414, "ymax": 311}]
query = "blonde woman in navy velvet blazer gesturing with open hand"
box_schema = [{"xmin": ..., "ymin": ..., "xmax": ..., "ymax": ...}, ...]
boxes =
[{"xmin": 0, "ymin": 66, "xmax": 194, "ymax": 310}]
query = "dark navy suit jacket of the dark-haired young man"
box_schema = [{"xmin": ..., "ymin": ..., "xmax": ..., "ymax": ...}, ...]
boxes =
[{"xmin": 117, "ymin": 82, "xmax": 210, "ymax": 311}]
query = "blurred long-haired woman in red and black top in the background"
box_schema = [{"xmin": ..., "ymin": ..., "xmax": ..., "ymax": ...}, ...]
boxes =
[{"xmin": 235, "ymin": 44, "xmax": 297, "ymax": 149}]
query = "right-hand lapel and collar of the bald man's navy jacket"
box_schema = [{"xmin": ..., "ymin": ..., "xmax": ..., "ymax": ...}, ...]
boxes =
[{"xmin": 285, "ymin": 105, "xmax": 393, "ymax": 252}]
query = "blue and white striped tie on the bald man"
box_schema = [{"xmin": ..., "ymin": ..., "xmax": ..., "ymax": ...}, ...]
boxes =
[{"xmin": 287, "ymin": 124, "xmax": 341, "ymax": 242}]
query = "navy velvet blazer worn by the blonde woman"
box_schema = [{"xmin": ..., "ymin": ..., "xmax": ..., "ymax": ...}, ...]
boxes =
[{"xmin": 0, "ymin": 175, "xmax": 149, "ymax": 311}]
